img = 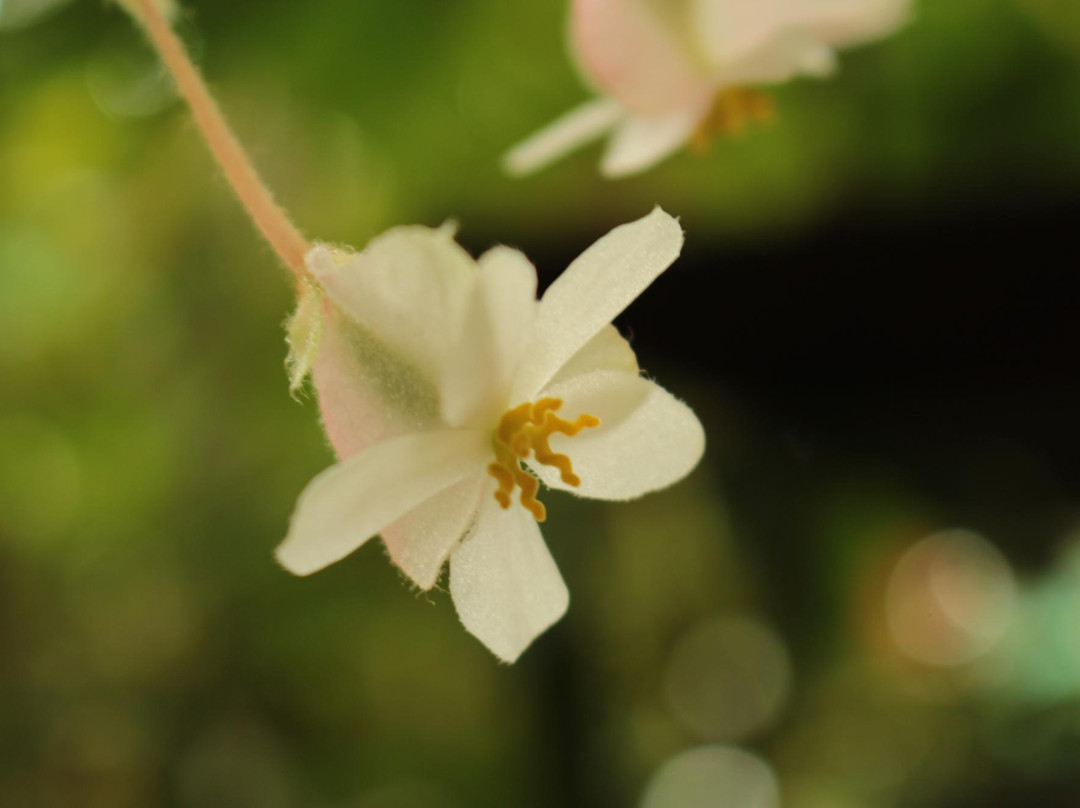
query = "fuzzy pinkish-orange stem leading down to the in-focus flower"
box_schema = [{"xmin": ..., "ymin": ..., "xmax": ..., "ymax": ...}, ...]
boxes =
[{"xmin": 133, "ymin": 0, "xmax": 310, "ymax": 280}]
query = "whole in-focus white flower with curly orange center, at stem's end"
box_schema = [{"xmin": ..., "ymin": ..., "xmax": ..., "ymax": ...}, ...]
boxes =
[{"xmin": 278, "ymin": 208, "xmax": 704, "ymax": 662}]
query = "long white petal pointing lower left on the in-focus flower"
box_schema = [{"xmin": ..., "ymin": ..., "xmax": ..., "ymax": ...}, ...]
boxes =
[{"xmin": 276, "ymin": 430, "xmax": 491, "ymax": 575}]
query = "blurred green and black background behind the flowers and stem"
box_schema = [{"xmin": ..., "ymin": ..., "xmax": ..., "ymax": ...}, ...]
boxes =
[{"xmin": 6, "ymin": 0, "xmax": 1080, "ymax": 808}]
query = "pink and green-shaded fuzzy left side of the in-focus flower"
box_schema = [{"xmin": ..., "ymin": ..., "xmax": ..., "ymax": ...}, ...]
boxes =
[{"xmin": 311, "ymin": 301, "xmax": 440, "ymax": 460}]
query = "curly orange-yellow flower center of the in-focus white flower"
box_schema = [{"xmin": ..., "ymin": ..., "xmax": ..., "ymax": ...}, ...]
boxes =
[{"xmin": 487, "ymin": 399, "xmax": 600, "ymax": 522}]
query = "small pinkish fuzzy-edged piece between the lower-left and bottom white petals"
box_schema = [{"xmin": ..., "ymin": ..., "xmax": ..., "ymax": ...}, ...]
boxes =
[{"xmin": 382, "ymin": 474, "xmax": 490, "ymax": 590}]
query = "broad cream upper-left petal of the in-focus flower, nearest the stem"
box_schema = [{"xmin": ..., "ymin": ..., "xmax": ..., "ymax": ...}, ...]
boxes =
[{"xmin": 308, "ymin": 227, "xmax": 476, "ymax": 377}]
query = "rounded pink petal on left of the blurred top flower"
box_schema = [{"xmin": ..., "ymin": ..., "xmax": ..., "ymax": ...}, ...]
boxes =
[{"xmin": 570, "ymin": 0, "xmax": 713, "ymax": 117}]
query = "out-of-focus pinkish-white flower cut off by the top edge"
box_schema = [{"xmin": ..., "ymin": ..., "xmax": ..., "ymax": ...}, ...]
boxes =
[{"xmin": 505, "ymin": 0, "xmax": 912, "ymax": 177}]
